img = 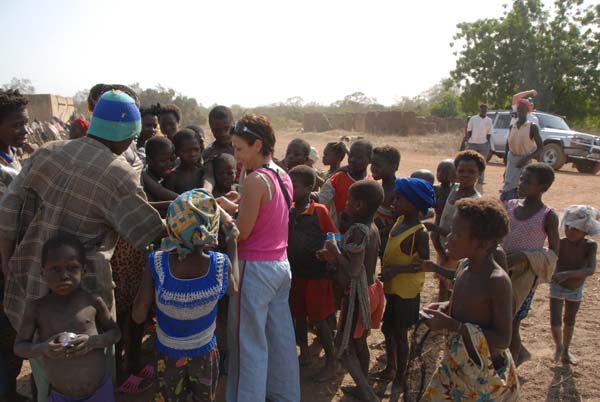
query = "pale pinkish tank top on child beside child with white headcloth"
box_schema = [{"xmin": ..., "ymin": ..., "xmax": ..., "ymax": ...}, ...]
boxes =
[{"xmin": 502, "ymin": 200, "xmax": 550, "ymax": 252}]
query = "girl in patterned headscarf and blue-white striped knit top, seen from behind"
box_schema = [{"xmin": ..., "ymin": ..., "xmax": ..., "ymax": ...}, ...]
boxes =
[{"xmin": 133, "ymin": 189, "xmax": 239, "ymax": 402}]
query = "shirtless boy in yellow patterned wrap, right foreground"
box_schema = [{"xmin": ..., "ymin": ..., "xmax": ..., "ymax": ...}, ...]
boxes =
[{"xmin": 423, "ymin": 198, "xmax": 518, "ymax": 401}]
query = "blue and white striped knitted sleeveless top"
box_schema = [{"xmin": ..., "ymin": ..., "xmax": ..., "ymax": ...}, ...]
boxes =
[{"xmin": 148, "ymin": 251, "xmax": 229, "ymax": 357}]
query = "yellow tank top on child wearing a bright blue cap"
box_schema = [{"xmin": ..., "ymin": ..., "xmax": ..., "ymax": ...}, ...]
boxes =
[{"xmin": 383, "ymin": 217, "xmax": 425, "ymax": 299}]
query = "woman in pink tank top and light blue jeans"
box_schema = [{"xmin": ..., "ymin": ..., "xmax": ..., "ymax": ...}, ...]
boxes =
[{"xmin": 227, "ymin": 115, "xmax": 300, "ymax": 402}]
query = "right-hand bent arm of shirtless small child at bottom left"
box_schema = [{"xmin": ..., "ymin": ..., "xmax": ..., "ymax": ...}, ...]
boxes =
[{"xmin": 67, "ymin": 295, "xmax": 121, "ymax": 357}]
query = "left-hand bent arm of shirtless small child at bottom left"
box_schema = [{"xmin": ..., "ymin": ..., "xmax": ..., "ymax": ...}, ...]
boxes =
[{"xmin": 14, "ymin": 301, "xmax": 65, "ymax": 359}]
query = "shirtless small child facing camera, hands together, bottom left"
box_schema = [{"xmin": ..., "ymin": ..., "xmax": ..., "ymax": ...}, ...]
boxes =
[{"xmin": 15, "ymin": 235, "xmax": 121, "ymax": 402}]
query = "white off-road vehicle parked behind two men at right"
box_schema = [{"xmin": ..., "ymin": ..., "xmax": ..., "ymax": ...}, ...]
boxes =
[{"xmin": 488, "ymin": 110, "xmax": 600, "ymax": 174}]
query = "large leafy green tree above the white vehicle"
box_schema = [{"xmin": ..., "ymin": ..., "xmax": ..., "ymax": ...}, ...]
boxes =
[{"xmin": 451, "ymin": 0, "xmax": 600, "ymax": 120}]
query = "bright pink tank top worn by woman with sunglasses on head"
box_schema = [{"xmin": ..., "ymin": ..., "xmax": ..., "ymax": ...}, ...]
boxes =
[{"xmin": 238, "ymin": 168, "xmax": 293, "ymax": 261}]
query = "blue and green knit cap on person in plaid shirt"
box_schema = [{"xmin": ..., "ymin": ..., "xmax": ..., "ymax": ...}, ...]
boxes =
[{"xmin": 88, "ymin": 90, "xmax": 142, "ymax": 142}]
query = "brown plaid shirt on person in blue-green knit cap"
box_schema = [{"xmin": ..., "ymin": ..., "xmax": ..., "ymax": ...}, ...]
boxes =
[{"xmin": 0, "ymin": 137, "xmax": 163, "ymax": 328}]
